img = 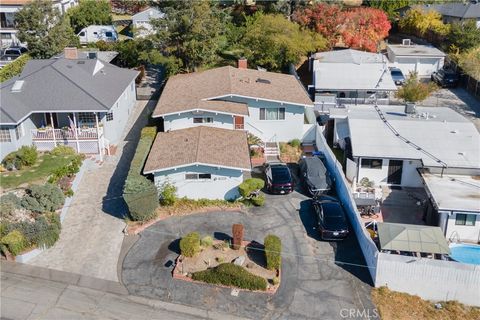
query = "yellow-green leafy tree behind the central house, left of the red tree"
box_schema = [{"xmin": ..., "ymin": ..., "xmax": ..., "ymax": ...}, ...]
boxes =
[{"xmin": 240, "ymin": 12, "xmax": 326, "ymax": 71}]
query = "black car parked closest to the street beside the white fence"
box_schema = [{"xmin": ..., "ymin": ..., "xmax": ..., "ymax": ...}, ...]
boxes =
[{"xmin": 313, "ymin": 196, "xmax": 348, "ymax": 240}]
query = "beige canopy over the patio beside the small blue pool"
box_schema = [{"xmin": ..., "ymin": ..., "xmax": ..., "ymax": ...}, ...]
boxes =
[{"xmin": 378, "ymin": 222, "xmax": 450, "ymax": 254}]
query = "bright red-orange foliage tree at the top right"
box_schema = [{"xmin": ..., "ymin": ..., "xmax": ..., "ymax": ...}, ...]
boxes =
[{"xmin": 294, "ymin": 3, "xmax": 391, "ymax": 52}]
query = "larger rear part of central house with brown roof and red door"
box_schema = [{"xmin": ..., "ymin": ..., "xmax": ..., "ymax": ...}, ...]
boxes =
[{"xmin": 152, "ymin": 61, "xmax": 313, "ymax": 142}]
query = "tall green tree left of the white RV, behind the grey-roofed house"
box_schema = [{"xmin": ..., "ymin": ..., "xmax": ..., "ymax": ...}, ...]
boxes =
[{"xmin": 15, "ymin": 0, "xmax": 79, "ymax": 59}]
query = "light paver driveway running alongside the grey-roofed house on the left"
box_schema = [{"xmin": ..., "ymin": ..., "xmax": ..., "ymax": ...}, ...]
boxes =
[{"xmin": 28, "ymin": 101, "xmax": 155, "ymax": 281}]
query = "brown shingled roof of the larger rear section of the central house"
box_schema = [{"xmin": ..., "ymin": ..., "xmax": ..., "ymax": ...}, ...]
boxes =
[{"xmin": 153, "ymin": 66, "xmax": 312, "ymax": 117}]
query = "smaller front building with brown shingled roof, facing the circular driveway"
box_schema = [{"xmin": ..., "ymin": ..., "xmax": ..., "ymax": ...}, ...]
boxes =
[{"xmin": 143, "ymin": 126, "xmax": 251, "ymax": 200}]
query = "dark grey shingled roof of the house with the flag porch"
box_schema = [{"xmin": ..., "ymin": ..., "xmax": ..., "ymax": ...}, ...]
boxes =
[{"xmin": 0, "ymin": 58, "xmax": 138, "ymax": 125}]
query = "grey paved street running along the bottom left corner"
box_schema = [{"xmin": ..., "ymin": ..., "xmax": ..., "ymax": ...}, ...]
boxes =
[{"xmin": 0, "ymin": 263, "xmax": 246, "ymax": 320}]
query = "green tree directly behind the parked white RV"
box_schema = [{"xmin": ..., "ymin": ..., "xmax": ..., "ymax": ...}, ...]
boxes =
[{"xmin": 68, "ymin": 0, "xmax": 112, "ymax": 33}]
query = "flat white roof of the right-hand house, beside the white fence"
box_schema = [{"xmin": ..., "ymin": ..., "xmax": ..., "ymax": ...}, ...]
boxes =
[{"xmin": 330, "ymin": 105, "xmax": 480, "ymax": 168}]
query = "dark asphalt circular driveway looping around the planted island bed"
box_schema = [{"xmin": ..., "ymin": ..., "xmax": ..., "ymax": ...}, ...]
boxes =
[{"xmin": 122, "ymin": 192, "xmax": 374, "ymax": 319}]
